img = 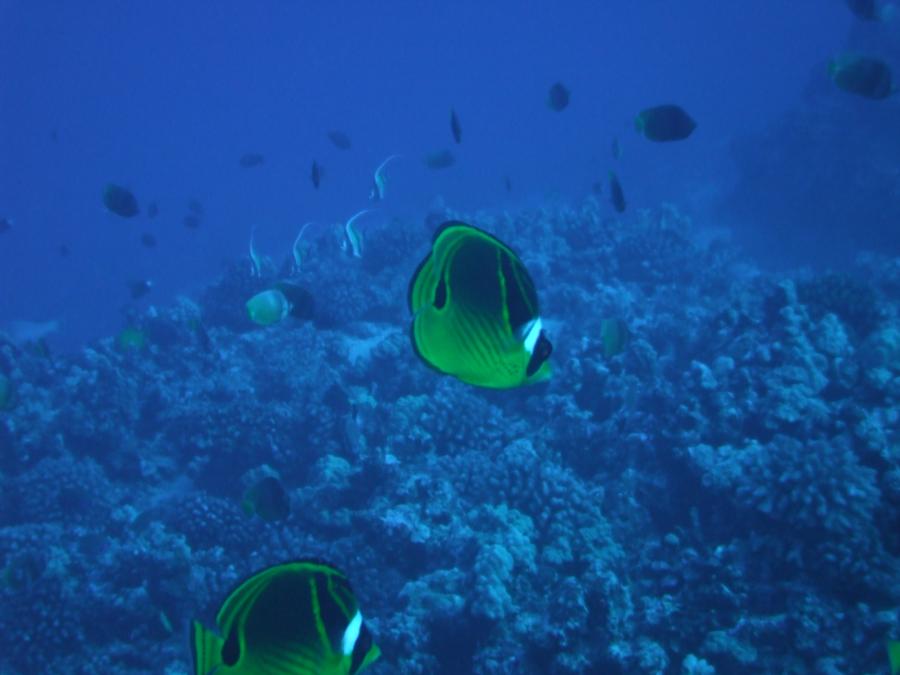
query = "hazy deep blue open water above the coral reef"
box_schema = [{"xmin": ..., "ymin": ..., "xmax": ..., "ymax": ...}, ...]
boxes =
[{"xmin": 0, "ymin": 0, "xmax": 868, "ymax": 346}]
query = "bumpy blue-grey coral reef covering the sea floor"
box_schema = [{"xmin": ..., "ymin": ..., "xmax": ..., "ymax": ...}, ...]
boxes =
[{"xmin": 0, "ymin": 198, "xmax": 900, "ymax": 675}]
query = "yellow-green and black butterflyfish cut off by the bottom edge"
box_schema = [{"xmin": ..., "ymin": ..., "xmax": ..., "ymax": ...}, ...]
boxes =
[{"xmin": 190, "ymin": 560, "xmax": 381, "ymax": 675}]
